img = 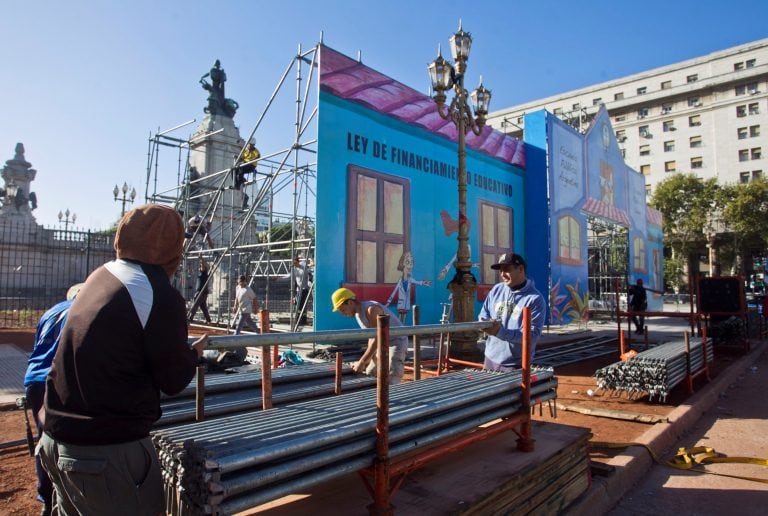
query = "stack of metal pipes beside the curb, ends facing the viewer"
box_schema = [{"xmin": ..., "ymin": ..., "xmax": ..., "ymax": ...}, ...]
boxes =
[{"xmin": 594, "ymin": 339, "xmax": 714, "ymax": 403}]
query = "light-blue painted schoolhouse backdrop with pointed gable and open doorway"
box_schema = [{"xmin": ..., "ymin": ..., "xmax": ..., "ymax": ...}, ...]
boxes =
[{"xmin": 536, "ymin": 107, "xmax": 663, "ymax": 324}]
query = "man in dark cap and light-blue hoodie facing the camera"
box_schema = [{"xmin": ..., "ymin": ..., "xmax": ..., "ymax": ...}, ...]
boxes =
[{"xmin": 480, "ymin": 253, "xmax": 547, "ymax": 372}]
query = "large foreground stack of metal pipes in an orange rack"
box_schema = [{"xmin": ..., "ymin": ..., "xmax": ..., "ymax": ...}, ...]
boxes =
[{"xmin": 153, "ymin": 368, "xmax": 557, "ymax": 514}]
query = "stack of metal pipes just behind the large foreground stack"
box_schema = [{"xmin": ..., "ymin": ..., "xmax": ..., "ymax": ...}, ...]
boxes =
[{"xmin": 155, "ymin": 362, "xmax": 376, "ymax": 427}]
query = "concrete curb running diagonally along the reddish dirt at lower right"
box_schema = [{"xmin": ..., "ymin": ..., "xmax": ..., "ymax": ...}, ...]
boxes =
[{"xmin": 565, "ymin": 340, "xmax": 766, "ymax": 516}]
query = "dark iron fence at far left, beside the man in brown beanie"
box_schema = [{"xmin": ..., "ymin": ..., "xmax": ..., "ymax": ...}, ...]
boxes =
[{"xmin": 0, "ymin": 221, "xmax": 115, "ymax": 328}]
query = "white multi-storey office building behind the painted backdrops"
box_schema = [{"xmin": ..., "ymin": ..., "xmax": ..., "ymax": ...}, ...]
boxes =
[{"xmin": 488, "ymin": 39, "xmax": 768, "ymax": 193}]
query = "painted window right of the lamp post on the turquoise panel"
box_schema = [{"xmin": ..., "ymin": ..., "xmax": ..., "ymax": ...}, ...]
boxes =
[{"xmin": 480, "ymin": 201, "xmax": 514, "ymax": 285}]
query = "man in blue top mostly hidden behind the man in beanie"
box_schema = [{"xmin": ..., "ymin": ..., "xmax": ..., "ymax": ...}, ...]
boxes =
[{"xmin": 24, "ymin": 283, "xmax": 83, "ymax": 516}]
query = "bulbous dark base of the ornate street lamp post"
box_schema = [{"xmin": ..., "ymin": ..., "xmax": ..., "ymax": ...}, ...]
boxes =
[{"xmin": 448, "ymin": 270, "xmax": 483, "ymax": 363}]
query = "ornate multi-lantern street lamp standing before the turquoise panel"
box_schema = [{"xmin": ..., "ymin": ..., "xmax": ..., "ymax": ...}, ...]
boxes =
[{"xmin": 428, "ymin": 22, "xmax": 491, "ymax": 358}]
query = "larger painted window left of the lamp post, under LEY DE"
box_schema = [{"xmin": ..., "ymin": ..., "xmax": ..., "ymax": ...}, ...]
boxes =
[{"xmin": 346, "ymin": 165, "xmax": 411, "ymax": 284}]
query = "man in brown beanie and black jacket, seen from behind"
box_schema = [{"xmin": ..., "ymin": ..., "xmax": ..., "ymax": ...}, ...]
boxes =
[{"xmin": 38, "ymin": 205, "xmax": 207, "ymax": 515}]
